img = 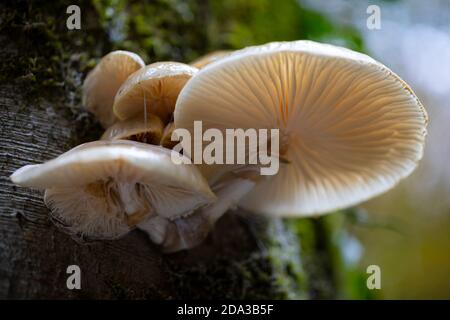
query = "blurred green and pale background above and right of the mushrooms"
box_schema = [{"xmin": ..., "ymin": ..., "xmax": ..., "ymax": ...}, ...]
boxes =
[{"xmin": 93, "ymin": 0, "xmax": 450, "ymax": 299}]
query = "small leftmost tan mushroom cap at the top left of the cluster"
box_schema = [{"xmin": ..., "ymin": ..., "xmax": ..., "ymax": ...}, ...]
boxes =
[{"xmin": 83, "ymin": 50, "xmax": 145, "ymax": 128}]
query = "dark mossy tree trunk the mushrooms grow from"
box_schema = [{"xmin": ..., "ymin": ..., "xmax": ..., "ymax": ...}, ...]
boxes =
[{"xmin": 0, "ymin": 1, "xmax": 336, "ymax": 299}]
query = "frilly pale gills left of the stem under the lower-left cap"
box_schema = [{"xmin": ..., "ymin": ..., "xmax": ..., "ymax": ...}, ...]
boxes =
[{"xmin": 44, "ymin": 179, "xmax": 154, "ymax": 241}]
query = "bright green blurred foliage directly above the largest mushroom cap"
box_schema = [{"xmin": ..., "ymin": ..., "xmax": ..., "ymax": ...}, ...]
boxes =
[{"xmin": 209, "ymin": 0, "xmax": 362, "ymax": 50}]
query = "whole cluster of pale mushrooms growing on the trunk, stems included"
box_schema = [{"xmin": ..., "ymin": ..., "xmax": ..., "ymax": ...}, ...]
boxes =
[{"xmin": 11, "ymin": 41, "xmax": 427, "ymax": 252}]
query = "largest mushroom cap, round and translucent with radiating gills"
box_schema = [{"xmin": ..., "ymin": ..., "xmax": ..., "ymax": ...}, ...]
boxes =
[{"xmin": 174, "ymin": 41, "xmax": 427, "ymax": 216}]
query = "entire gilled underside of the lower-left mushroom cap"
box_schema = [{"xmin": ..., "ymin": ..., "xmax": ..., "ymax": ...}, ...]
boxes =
[{"xmin": 44, "ymin": 176, "xmax": 211, "ymax": 240}]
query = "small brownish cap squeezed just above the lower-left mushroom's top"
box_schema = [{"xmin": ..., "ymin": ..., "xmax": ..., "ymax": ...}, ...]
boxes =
[{"xmin": 101, "ymin": 114, "xmax": 164, "ymax": 144}]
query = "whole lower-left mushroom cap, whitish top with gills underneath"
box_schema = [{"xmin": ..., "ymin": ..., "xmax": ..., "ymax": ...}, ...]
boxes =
[{"xmin": 11, "ymin": 140, "xmax": 215, "ymax": 238}]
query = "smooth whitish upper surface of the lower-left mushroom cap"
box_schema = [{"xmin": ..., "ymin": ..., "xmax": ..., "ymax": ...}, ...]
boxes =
[{"xmin": 11, "ymin": 140, "xmax": 214, "ymax": 198}]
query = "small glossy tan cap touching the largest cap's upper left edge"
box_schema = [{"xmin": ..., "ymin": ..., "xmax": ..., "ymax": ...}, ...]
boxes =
[{"xmin": 114, "ymin": 62, "xmax": 198, "ymax": 122}]
